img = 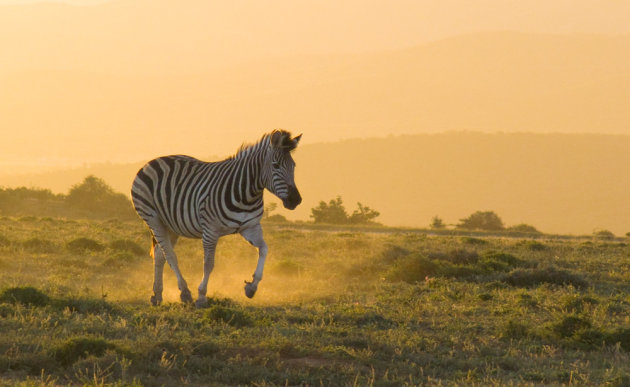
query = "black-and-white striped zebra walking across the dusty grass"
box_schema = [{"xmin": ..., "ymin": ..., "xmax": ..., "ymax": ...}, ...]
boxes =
[{"xmin": 131, "ymin": 130, "xmax": 302, "ymax": 307}]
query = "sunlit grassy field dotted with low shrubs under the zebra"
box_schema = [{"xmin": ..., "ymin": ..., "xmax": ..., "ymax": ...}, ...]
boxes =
[{"xmin": 0, "ymin": 217, "xmax": 630, "ymax": 386}]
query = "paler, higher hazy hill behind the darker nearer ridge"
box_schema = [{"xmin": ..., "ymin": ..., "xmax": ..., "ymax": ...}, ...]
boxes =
[{"xmin": 0, "ymin": 32, "xmax": 630, "ymax": 169}]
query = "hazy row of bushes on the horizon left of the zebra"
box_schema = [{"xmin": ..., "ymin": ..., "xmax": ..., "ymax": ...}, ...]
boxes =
[{"xmin": 0, "ymin": 175, "xmax": 136, "ymax": 219}]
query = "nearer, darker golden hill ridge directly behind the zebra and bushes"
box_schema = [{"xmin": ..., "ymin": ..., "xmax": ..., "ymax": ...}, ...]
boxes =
[{"xmin": 0, "ymin": 132, "xmax": 630, "ymax": 235}]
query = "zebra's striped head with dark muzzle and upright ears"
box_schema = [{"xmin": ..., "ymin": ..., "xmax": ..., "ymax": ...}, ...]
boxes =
[{"xmin": 264, "ymin": 130, "xmax": 302, "ymax": 210}]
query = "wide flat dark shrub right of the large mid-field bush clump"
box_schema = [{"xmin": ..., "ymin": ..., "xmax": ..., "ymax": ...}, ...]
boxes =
[{"xmin": 503, "ymin": 266, "xmax": 588, "ymax": 289}]
